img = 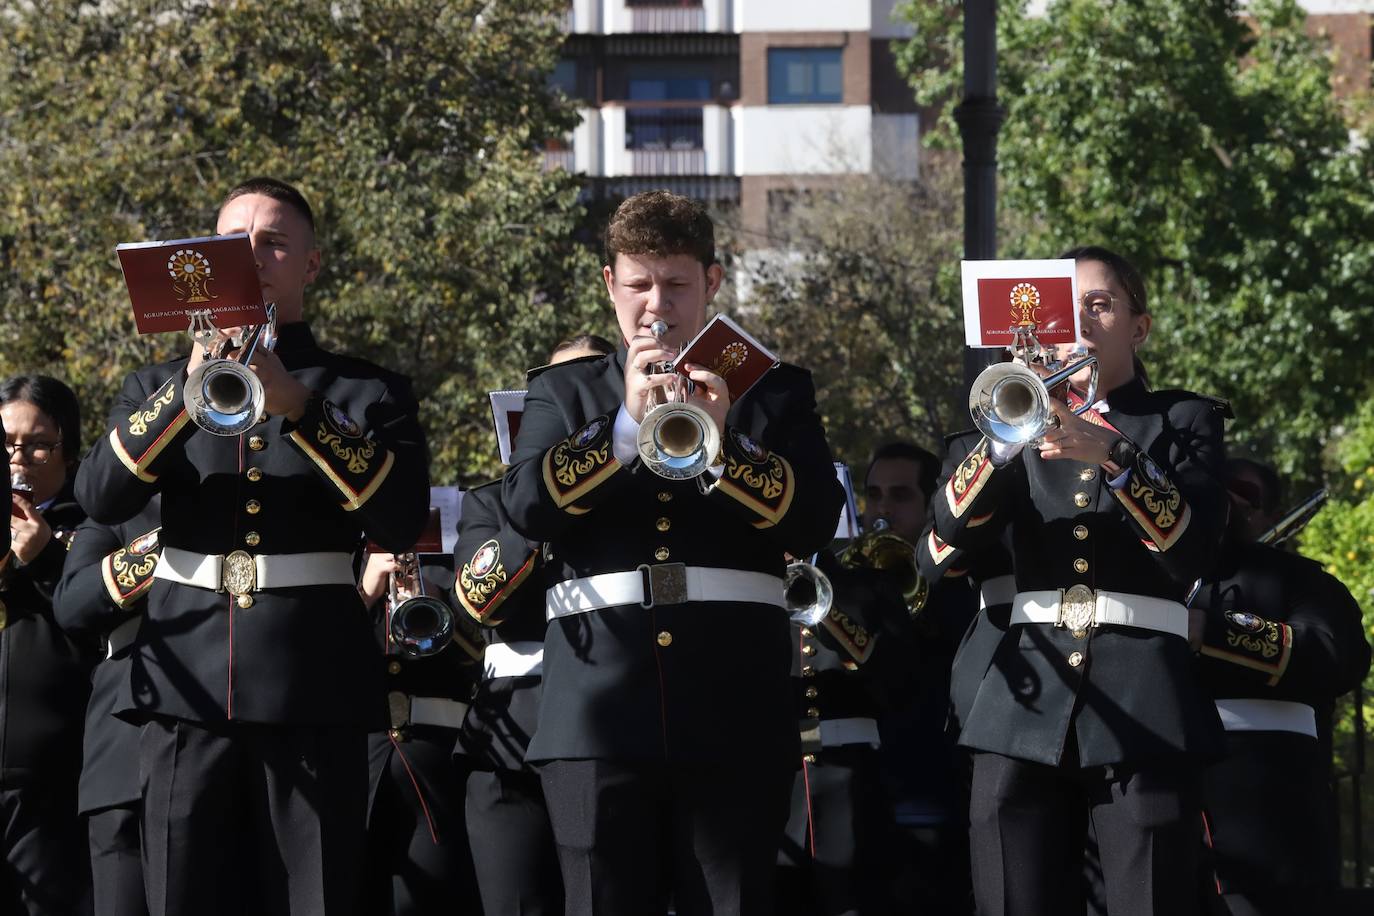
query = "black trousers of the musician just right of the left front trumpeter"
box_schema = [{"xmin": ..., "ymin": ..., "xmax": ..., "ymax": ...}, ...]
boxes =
[{"xmin": 364, "ymin": 726, "xmax": 482, "ymax": 916}]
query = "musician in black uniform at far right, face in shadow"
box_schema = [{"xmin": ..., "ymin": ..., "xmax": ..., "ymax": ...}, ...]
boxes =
[{"xmin": 1194, "ymin": 459, "xmax": 1370, "ymax": 916}]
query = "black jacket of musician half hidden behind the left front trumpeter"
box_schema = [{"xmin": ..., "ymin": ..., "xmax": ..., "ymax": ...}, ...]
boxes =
[{"xmin": 54, "ymin": 499, "xmax": 161, "ymax": 814}]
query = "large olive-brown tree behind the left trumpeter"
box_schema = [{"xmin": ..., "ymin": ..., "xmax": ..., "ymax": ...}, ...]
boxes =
[{"xmin": 0, "ymin": 0, "xmax": 609, "ymax": 482}]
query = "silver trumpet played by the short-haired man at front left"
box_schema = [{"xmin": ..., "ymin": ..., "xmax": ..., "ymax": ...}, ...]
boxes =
[{"xmin": 183, "ymin": 305, "xmax": 276, "ymax": 435}]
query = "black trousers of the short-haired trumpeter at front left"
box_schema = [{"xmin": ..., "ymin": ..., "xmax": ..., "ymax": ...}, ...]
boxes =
[{"xmin": 139, "ymin": 717, "xmax": 367, "ymax": 916}]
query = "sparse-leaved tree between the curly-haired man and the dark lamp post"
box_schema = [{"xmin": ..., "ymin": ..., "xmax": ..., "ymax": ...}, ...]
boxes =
[{"xmin": 743, "ymin": 157, "xmax": 969, "ymax": 470}]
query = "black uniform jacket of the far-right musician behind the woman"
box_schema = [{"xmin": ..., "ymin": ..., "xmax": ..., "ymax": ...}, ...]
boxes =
[{"xmin": 1194, "ymin": 544, "xmax": 1370, "ymax": 889}]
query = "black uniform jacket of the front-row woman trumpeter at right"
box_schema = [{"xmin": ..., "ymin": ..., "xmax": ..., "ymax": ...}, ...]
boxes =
[{"xmin": 922, "ymin": 379, "xmax": 1226, "ymax": 766}]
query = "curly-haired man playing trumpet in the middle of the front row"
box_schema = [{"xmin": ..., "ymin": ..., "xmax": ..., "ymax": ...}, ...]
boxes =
[{"xmin": 502, "ymin": 191, "xmax": 844, "ymax": 916}]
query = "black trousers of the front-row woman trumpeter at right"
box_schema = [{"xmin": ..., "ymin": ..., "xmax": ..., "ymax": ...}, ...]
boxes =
[{"xmin": 969, "ymin": 754, "xmax": 1202, "ymax": 916}]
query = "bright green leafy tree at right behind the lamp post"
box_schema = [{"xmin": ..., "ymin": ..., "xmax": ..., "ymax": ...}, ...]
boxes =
[{"xmin": 901, "ymin": 0, "xmax": 1374, "ymax": 483}]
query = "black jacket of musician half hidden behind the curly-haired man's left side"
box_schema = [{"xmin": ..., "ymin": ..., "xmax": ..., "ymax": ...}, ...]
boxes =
[{"xmin": 453, "ymin": 481, "xmax": 545, "ymax": 770}]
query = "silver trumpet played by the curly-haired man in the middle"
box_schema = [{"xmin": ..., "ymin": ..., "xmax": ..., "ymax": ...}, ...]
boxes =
[{"xmin": 636, "ymin": 321, "xmax": 720, "ymax": 481}]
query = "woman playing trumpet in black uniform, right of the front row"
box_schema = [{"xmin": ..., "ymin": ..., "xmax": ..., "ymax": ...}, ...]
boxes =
[{"xmin": 922, "ymin": 247, "xmax": 1228, "ymax": 916}]
